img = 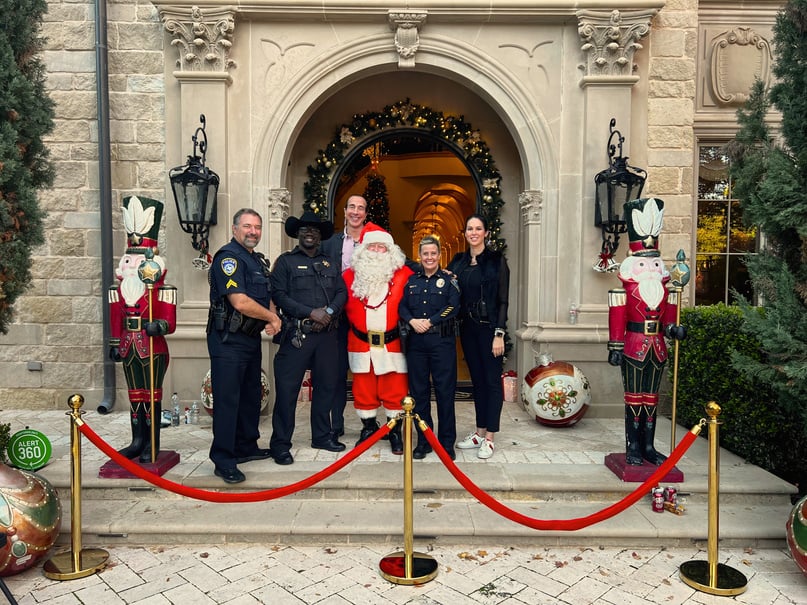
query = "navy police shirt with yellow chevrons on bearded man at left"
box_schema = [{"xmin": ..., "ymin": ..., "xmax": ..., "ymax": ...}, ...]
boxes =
[{"xmin": 210, "ymin": 238, "xmax": 270, "ymax": 309}]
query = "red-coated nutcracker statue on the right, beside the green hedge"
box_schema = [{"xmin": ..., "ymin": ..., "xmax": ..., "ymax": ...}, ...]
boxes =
[{"xmin": 608, "ymin": 198, "xmax": 686, "ymax": 465}]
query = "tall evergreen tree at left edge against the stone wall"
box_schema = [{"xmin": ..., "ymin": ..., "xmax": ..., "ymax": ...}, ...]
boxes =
[{"xmin": 0, "ymin": 0, "xmax": 54, "ymax": 334}]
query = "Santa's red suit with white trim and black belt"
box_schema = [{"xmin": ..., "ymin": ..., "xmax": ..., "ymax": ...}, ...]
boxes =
[{"xmin": 343, "ymin": 266, "xmax": 412, "ymax": 418}]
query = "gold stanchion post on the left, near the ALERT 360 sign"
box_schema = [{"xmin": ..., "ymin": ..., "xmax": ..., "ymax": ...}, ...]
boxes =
[{"xmin": 42, "ymin": 395, "xmax": 109, "ymax": 580}]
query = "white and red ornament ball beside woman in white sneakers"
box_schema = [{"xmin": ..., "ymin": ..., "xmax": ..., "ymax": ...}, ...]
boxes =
[{"xmin": 521, "ymin": 355, "xmax": 591, "ymax": 427}]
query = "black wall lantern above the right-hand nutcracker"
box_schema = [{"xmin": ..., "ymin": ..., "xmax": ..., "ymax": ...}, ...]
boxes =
[{"xmin": 594, "ymin": 118, "xmax": 647, "ymax": 272}]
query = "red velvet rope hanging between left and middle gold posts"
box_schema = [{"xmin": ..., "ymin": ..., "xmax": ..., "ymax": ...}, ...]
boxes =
[{"xmin": 76, "ymin": 418, "xmax": 390, "ymax": 502}]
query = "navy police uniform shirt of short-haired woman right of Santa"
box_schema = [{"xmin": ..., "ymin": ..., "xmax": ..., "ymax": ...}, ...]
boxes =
[{"xmin": 399, "ymin": 269, "xmax": 460, "ymax": 327}]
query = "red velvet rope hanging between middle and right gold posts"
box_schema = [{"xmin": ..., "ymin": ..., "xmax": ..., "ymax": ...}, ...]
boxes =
[{"xmin": 420, "ymin": 423, "xmax": 698, "ymax": 531}]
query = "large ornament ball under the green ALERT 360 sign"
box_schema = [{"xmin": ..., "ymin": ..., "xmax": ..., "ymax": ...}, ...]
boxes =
[{"xmin": 0, "ymin": 463, "xmax": 62, "ymax": 576}]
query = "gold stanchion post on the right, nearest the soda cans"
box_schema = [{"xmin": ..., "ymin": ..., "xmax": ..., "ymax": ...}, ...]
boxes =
[{"xmin": 678, "ymin": 401, "xmax": 748, "ymax": 597}]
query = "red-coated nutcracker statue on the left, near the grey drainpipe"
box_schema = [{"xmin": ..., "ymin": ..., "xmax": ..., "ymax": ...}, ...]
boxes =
[{"xmin": 109, "ymin": 196, "xmax": 176, "ymax": 462}]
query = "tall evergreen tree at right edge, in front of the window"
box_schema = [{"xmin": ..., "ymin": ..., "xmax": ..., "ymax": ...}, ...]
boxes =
[{"xmin": 729, "ymin": 0, "xmax": 807, "ymax": 432}]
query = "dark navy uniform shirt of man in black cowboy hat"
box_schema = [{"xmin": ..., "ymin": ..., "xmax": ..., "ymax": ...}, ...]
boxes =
[{"xmin": 271, "ymin": 246, "xmax": 347, "ymax": 319}]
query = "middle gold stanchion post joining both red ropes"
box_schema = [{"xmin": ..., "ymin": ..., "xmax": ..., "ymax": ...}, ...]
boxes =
[{"xmin": 379, "ymin": 396, "xmax": 437, "ymax": 586}]
